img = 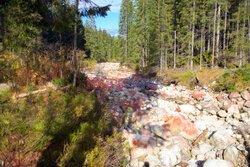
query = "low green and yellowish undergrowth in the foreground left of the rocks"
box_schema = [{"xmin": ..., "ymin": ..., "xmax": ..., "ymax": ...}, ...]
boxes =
[{"xmin": 0, "ymin": 88, "xmax": 123, "ymax": 166}]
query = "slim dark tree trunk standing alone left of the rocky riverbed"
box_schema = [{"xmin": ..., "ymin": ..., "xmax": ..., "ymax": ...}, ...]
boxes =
[{"xmin": 73, "ymin": 0, "xmax": 79, "ymax": 87}]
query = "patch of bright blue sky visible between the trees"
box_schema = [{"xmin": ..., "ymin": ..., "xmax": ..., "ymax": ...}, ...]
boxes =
[{"xmin": 80, "ymin": 0, "xmax": 122, "ymax": 36}]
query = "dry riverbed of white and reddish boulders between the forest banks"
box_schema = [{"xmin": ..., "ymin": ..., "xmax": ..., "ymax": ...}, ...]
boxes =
[{"xmin": 82, "ymin": 63, "xmax": 250, "ymax": 167}]
